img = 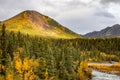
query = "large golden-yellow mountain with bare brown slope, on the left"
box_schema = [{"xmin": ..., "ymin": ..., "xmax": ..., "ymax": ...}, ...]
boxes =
[{"xmin": 2, "ymin": 10, "xmax": 80, "ymax": 38}]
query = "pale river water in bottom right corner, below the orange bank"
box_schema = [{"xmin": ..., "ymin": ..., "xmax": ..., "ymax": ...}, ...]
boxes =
[{"xmin": 92, "ymin": 70, "xmax": 120, "ymax": 80}]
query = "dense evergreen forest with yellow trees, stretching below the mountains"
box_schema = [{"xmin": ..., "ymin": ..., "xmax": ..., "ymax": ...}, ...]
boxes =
[{"xmin": 0, "ymin": 25, "xmax": 120, "ymax": 80}]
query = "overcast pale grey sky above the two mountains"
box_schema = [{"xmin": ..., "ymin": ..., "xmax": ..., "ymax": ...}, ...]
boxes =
[{"xmin": 0, "ymin": 0, "xmax": 120, "ymax": 34}]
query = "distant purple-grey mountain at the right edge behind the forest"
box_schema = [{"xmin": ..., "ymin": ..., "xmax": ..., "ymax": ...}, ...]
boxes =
[{"xmin": 83, "ymin": 24, "xmax": 120, "ymax": 37}]
